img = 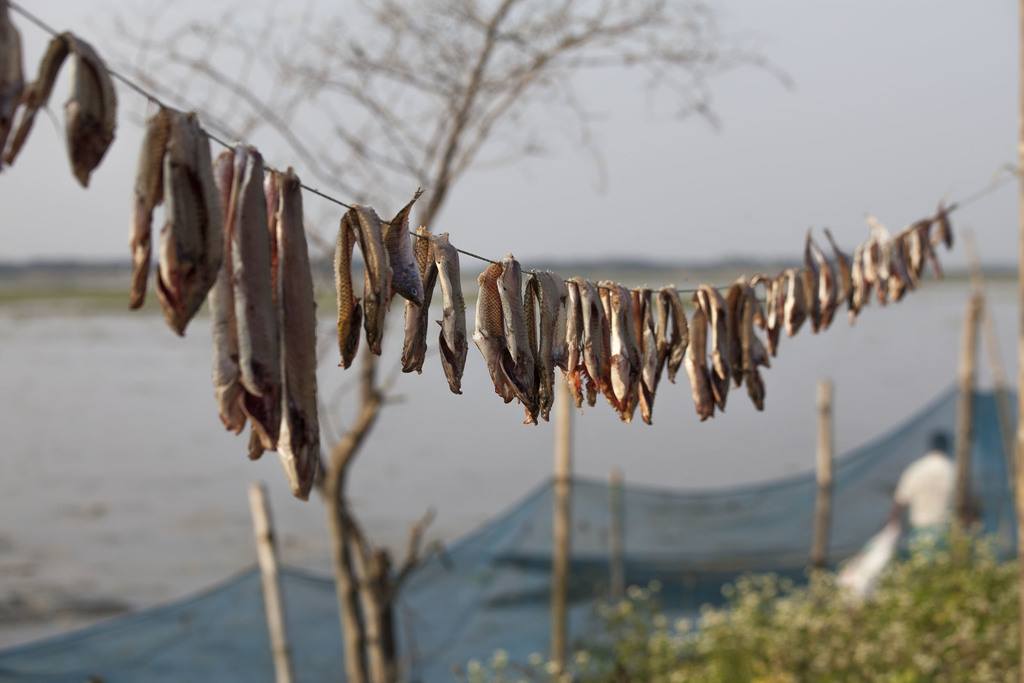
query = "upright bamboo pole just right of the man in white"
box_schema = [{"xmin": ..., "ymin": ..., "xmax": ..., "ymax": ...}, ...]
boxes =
[{"xmin": 954, "ymin": 292, "xmax": 982, "ymax": 529}]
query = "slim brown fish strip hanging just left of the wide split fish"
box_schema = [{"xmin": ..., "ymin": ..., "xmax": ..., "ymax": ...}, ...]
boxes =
[{"xmin": 128, "ymin": 108, "xmax": 172, "ymax": 308}]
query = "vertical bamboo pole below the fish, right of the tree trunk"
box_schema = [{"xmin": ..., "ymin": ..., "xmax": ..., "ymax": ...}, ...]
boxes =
[{"xmin": 551, "ymin": 382, "xmax": 572, "ymax": 673}]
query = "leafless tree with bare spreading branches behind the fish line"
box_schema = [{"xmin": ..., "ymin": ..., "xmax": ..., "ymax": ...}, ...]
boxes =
[{"xmin": 108, "ymin": 0, "xmax": 771, "ymax": 683}]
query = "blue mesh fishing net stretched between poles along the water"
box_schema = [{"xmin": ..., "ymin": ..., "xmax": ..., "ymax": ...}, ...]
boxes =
[{"xmin": 0, "ymin": 391, "xmax": 1016, "ymax": 683}]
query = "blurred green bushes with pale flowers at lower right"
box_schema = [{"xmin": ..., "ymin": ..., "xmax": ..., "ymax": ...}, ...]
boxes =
[{"xmin": 466, "ymin": 536, "xmax": 1019, "ymax": 683}]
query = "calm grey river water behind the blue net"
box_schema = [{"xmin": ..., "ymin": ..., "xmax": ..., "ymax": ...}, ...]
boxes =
[{"xmin": 0, "ymin": 282, "xmax": 1016, "ymax": 647}]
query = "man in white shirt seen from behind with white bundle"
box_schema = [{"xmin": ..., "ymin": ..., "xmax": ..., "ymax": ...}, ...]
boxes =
[{"xmin": 838, "ymin": 431, "xmax": 956, "ymax": 597}]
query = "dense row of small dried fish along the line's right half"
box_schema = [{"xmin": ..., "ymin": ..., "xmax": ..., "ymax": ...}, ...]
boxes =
[{"xmin": 460, "ymin": 205, "xmax": 952, "ymax": 424}]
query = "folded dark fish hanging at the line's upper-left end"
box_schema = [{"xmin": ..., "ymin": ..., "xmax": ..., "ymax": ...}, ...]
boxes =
[{"xmin": 0, "ymin": 0, "xmax": 118, "ymax": 187}]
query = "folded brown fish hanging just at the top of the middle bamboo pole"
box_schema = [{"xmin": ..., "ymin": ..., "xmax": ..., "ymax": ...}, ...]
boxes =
[{"xmin": 523, "ymin": 270, "xmax": 562, "ymax": 424}]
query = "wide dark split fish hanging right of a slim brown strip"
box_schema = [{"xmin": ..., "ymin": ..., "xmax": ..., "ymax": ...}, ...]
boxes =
[{"xmin": 157, "ymin": 112, "xmax": 223, "ymax": 335}]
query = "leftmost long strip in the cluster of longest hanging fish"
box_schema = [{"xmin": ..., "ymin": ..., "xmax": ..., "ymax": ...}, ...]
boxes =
[{"xmin": 208, "ymin": 150, "xmax": 246, "ymax": 434}]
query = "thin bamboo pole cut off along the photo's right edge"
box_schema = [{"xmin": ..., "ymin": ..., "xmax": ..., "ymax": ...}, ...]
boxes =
[{"xmin": 1015, "ymin": 0, "xmax": 1024, "ymax": 674}]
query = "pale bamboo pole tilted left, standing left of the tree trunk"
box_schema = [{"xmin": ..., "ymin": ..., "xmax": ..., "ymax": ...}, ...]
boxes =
[{"xmin": 249, "ymin": 481, "xmax": 292, "ymax": 683}]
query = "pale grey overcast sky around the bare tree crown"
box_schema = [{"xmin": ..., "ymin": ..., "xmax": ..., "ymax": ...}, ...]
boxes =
[{"xmin": 0, "ymin": 0, "xmax": 1017, "ymax": 264}]
